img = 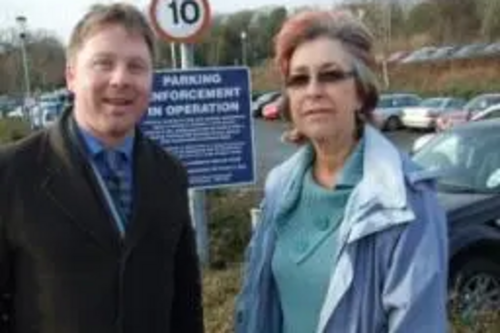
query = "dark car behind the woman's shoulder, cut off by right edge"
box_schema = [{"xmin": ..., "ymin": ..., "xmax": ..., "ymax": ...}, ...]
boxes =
[{"xmin": 413, "ymin": 119, "xmax": 500, "ymax": 316}]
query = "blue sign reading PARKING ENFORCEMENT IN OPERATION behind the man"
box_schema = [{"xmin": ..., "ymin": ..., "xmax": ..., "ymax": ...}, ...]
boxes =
[{"xmin": 141, "ymin": 67, "xmax": 255, "ymax": 189}]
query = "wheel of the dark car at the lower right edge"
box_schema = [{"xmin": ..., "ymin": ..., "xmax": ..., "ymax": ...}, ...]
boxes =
[{"xmin": 450, "ymin": 257, "xmax": 500, "ymax": 318}]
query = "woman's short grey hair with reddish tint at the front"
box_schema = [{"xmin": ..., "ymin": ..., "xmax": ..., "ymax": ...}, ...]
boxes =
[{"xmin": 274, "ymin": 10, "xmax": 378, "ymax": 142}]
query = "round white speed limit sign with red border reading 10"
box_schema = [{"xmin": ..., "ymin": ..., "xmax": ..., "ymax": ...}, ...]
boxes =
[{"xmin": 149, "ymin": 0, "xmax": 210, "ymax": 43}]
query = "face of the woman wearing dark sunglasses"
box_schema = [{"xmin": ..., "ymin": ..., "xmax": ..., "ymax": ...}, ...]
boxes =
[{"xmin": 286, "ymin": 37, "xmax": 362, "ymax": 142}]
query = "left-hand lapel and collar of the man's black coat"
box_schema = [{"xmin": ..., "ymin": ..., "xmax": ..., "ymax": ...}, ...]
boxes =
[{"xmin": 41, "ymin": 114, "xmax": 120, "ymax": 250}]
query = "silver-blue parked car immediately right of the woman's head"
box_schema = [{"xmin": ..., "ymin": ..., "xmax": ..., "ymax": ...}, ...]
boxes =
[{"xmin": 373, "ymin": 93, "xmax": 422, "ymax": 131}]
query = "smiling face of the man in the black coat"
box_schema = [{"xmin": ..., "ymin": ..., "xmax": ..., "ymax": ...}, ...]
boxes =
[{"xmin": 66, "ymin": 25, "xmax": 152, "ymax": 144}]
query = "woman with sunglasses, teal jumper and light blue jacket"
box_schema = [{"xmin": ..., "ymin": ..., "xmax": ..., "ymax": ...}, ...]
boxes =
[{"xmin": 236, "ymin": 11, "xmax": 447, "ymax": 333}]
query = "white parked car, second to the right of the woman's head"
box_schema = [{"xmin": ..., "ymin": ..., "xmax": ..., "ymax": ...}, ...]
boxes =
[{"xmin": 401, "ymin": 97, "xmax": 465, "ymax": 129}]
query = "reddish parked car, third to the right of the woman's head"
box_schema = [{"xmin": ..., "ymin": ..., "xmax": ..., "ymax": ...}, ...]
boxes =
[{"xmin": 436, "ymin": 93, "xmax": 500, "ymax": 131}]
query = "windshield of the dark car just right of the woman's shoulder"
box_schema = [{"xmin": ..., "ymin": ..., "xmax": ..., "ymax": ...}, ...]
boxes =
[{"xmin": 413, "ymin": 126, "xmax": 500, "ymax": 193}]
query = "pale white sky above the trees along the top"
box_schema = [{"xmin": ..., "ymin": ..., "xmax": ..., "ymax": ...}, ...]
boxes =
[{"xmin": 0, "ymin": 0, "xmax": 341, "ymax": 44}]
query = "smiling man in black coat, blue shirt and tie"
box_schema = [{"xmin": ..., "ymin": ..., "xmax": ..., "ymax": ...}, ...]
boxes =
[{"xmin": 0, "ymin": 4, "xmax": 203, "ymax": 333}]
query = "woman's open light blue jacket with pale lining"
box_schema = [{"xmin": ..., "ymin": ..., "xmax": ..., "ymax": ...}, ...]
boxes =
[{"xmin": 235, "ymin": 126, "xmax": 448, "ymax": 333}]
